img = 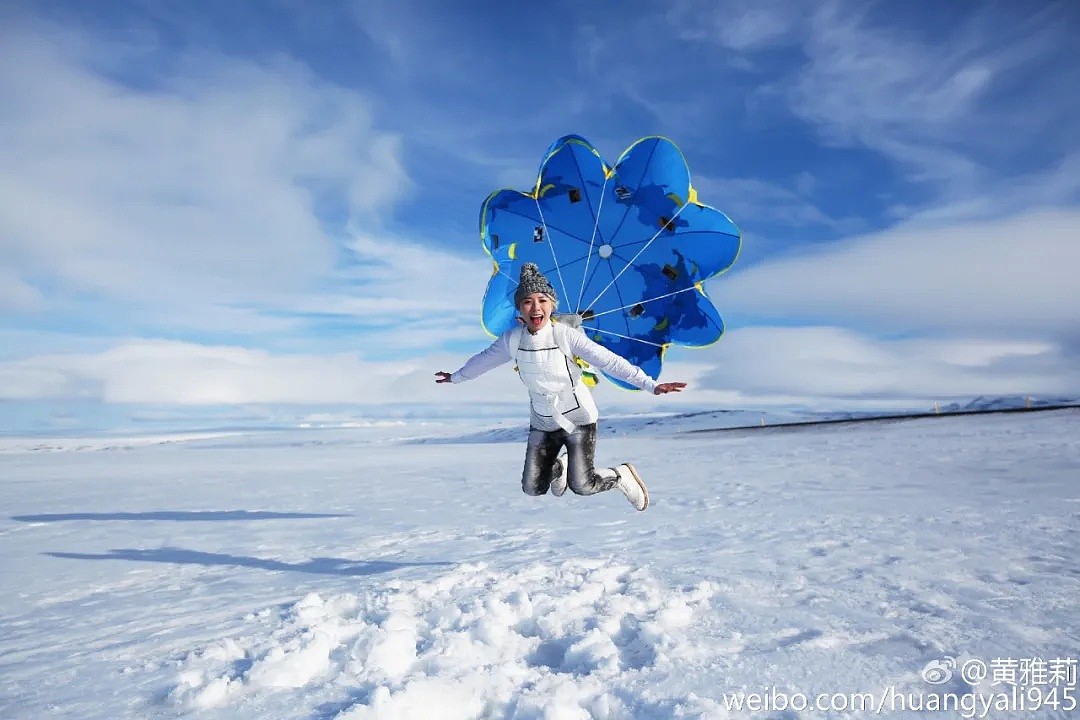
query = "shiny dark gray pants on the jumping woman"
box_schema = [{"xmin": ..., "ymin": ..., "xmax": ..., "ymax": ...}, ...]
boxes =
[{"xmin": 522, "ymin": 422, "xmax": 619, "ymax": 495}]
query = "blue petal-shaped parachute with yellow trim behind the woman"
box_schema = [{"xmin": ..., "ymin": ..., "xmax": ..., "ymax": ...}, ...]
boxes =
[{"xmin": 480, "ymin": 135, "xmax": 742, "ymax": 388}]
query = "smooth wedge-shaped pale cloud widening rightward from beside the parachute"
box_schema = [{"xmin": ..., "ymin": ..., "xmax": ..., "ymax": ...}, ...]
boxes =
[{"xmin": 708, "ymin": 210, "xmax": 1080, "ymax": 338}]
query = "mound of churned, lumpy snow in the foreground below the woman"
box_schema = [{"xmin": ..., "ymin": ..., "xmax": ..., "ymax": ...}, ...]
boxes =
[{"xmin": 171, "ymin": 560, "xmax": 715, "ymax": 720}]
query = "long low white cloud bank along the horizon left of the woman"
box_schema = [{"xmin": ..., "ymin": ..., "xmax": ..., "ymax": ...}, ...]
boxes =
[{"xmin": 0, "ymin": 340, "xmax": 540, "ymax": 408}]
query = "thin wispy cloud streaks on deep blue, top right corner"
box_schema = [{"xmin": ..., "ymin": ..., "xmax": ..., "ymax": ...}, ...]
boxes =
[{"xmin": 788, "ymin": 2, "xmax": 1080, "ymax": 201}]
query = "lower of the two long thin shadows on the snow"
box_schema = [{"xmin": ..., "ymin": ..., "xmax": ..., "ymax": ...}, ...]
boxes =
[{"xmin": 44, "ymin": 547, "xmax": 454, "ymax": 576}]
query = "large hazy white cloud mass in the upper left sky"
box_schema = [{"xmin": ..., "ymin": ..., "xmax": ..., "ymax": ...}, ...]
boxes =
[{"xmin": 0, "ymin": 21, "xmax": 408, "ymax": 320}]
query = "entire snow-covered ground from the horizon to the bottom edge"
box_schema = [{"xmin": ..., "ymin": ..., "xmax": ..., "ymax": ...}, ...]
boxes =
[{"xmin": 0, "ymin": 410, "xmax": 1080, "ymax": 720}]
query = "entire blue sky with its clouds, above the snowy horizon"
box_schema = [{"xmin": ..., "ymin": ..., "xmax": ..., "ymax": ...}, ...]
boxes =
[{"xmin": 0, "ymin": 0, "xmax": 1080, "ymax": 430}]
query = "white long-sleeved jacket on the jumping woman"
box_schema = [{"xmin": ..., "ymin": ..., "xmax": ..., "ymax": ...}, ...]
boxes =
[{"xmin": 450, "ymin": 322, "xmax": 657, "ymax": 432}]
